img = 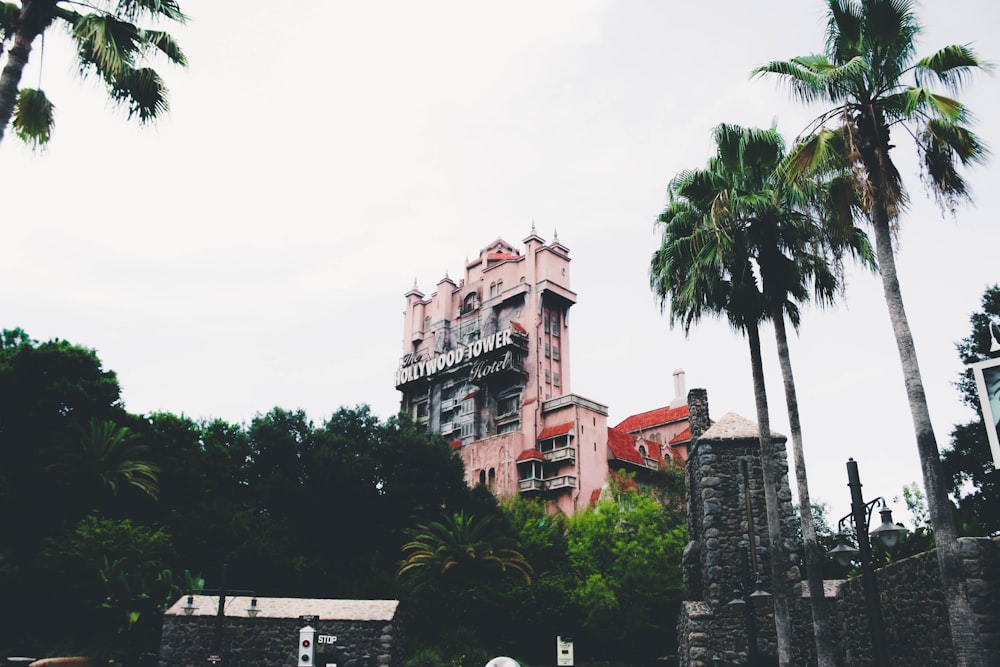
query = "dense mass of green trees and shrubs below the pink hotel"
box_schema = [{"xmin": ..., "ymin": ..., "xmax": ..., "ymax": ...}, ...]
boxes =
[{"xmin": 0, "ymin": 330, "xmax": 687, "ymax": 667}]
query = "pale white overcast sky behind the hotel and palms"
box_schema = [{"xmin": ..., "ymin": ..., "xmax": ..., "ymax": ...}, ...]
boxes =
[{"xmin": 0, "ymin": 0, "xmax": 1000, "ymax": 520}]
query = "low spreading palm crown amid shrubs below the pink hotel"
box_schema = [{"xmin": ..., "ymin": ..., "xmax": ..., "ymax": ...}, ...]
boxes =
[{"xmin": 396, "ymin": 512, "xmax": 532, "ymax": 584}]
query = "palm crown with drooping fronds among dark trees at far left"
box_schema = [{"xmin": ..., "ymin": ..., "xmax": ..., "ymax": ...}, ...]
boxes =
[{"xmin": 48, "ymin": 418, "xmax": 160, "ymax": 504}]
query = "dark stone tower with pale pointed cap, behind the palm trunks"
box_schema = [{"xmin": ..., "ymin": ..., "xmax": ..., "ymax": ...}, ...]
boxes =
[{"xmin": 678, "ymin": 412, "xmax": 798, "ymax": 667}]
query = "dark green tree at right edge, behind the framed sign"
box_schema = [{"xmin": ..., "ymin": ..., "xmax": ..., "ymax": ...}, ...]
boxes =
[{"xmin": 942, "ymin": 285, "xmax": 1000, "ymax": 535}]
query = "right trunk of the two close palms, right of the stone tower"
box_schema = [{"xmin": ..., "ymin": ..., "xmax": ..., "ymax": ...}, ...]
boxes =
[{"xmin": 771, "ymin": 309, "xmax": 836, "ymax": 667}]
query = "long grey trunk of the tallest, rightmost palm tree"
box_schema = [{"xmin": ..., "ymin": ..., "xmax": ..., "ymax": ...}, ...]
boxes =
[{"xmin": 869, "ymin": 197, "xmax": 985, "ymax": 667}]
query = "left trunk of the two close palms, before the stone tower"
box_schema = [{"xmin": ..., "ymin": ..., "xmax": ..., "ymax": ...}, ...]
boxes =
[{"xmin": 746, "ymin": 322, "xmax": 792, "ymax": 667}]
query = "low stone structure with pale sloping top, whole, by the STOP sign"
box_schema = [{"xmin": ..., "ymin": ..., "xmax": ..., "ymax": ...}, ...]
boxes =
[{"xmin": 158, "ymin": 595, "xmax": 403, "ymax": 667}]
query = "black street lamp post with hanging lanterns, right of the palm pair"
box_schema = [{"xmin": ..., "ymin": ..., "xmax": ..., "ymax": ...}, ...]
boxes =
[{"xmin": 828, "ymin": 459, "xmax": 906, "ymax": 667}]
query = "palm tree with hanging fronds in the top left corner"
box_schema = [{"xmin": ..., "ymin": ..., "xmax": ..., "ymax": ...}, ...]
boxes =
[{"xmin": 0, "ymin": 0, "xmax": 187, "ymax": 146}]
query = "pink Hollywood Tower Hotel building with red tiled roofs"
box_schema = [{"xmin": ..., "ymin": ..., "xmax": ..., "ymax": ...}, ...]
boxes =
[{"xmin": 395, "ymin": 228, "xmax": 690, "ymax": 513}]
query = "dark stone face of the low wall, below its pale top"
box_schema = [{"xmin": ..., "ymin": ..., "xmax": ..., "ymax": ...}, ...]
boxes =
[{"xmin": 158, "ymin": 616, "xmax": 403, "ymax": 667}]
